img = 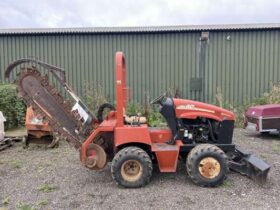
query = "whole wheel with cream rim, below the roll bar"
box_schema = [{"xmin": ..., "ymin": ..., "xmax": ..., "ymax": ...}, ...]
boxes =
[{"xmin": 111, "ymin": 146, "xmax": 153, "ymax": 188}]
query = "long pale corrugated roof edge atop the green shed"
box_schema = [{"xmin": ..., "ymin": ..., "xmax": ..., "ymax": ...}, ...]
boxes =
[{"xmin": 0, "ymin": 23, "xmax": 280, "ymax": 35}]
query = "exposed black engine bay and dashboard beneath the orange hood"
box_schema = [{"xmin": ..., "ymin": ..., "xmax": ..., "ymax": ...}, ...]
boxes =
[{"xmin": 158, "ymin": 97, "xmax": 234, "ymax": 144}]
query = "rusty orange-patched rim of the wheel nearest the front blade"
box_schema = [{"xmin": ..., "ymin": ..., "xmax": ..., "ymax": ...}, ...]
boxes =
[{"xmin": 198, "ymin": 157, "xmax": 221, "ymax": 179}]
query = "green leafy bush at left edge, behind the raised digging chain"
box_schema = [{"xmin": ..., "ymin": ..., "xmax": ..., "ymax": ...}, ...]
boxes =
[{"xmin": 0, "ymin": 84, "xmax": 26, "ymax": 129}]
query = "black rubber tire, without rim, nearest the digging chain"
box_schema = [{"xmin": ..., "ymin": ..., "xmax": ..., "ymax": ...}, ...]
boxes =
[{"xmin": 111, "ymin": 146, "xmax": 153, "ymax": 188}]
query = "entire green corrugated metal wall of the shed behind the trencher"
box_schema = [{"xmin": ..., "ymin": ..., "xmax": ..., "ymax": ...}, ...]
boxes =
[{"xmin": 0, "ymin": 30, "xmax": 280, "ymax": 103}]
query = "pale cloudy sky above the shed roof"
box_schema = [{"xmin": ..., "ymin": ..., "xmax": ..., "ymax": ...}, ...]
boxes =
[{"xmin": 0, "ymin": 0, "xmax": 280, "ymax": 28}]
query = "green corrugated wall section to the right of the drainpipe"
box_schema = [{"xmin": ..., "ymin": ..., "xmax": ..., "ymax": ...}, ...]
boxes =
[{"xmin": 205, "ymin": 31, "xmax": 280, "ymax": 104}]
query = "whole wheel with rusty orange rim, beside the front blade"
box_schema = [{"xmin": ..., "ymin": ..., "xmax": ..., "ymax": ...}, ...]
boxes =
[{"xmin": 186, "ymin": 144, "xmax": 229, "ymax": 187}]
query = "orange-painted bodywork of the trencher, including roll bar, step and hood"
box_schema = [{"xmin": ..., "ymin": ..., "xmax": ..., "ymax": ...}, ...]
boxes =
[{"xmin": 81, "ymin": 52, "xmax": 235, "ymax": 172}]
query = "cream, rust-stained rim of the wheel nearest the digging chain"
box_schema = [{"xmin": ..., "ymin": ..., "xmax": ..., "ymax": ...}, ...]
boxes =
[{"xmin": 121, "ymin": 160, "xmax": 143, "ymax": 182}]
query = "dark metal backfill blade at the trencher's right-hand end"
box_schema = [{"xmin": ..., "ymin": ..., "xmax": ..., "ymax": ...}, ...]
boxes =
[{"xmin": 229, "ymin": 148, "xmax": 271, "ymax": 185}]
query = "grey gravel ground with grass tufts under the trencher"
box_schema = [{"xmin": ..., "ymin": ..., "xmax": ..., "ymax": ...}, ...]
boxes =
[{"xmin": 0, "ymin": 129, "xmax": 280, "ymax": 210}]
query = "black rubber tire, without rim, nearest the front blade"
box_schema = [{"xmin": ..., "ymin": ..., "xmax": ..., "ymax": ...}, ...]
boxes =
[{"xmin": 186, "ymin": 144, "xmax": 229, "ymax": 187}]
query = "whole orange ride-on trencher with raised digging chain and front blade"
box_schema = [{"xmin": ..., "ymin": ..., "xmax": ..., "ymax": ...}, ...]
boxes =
[{"xmin": 5, "ymin": 52, "xmax": 270, "ymax": 187}]
